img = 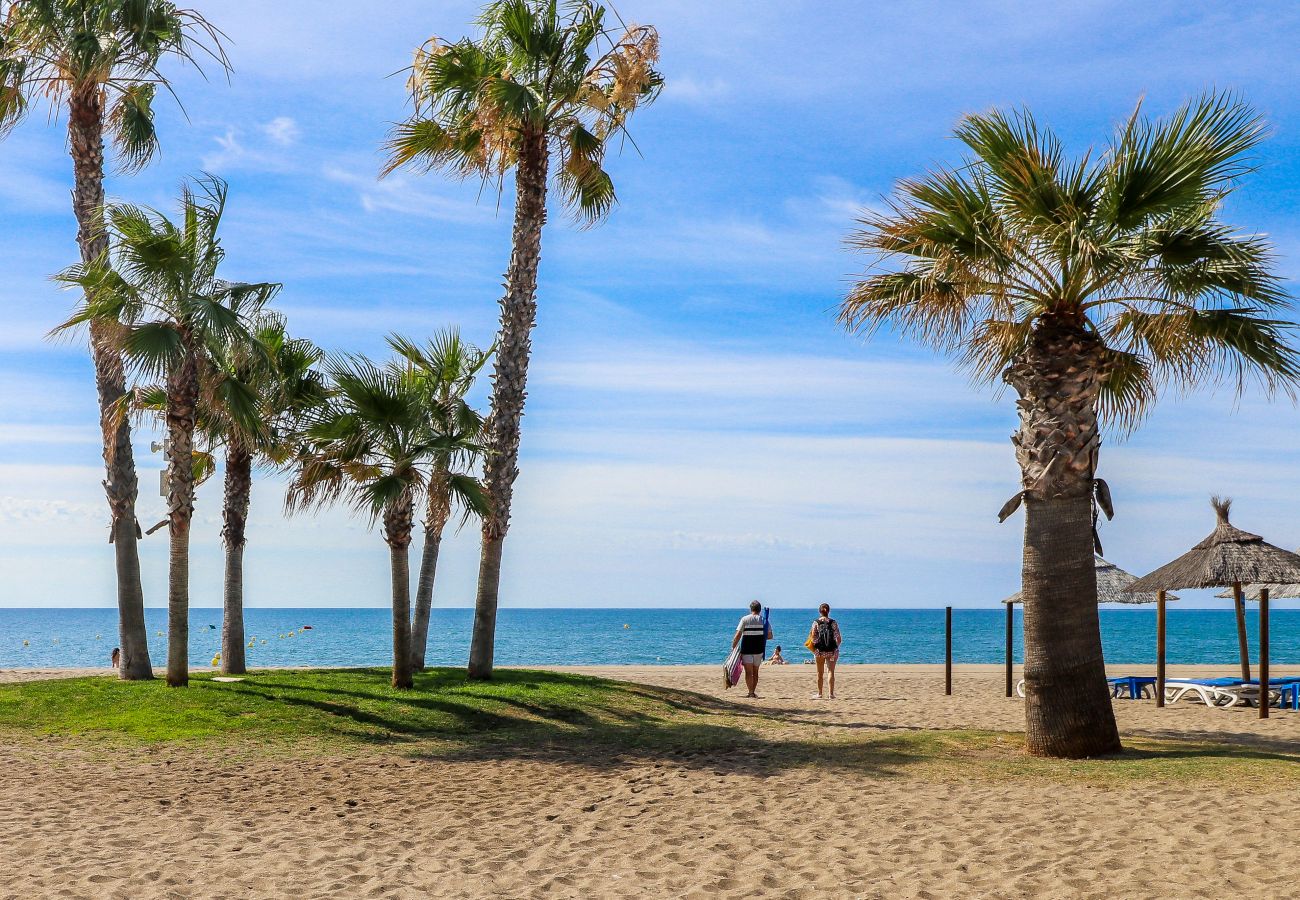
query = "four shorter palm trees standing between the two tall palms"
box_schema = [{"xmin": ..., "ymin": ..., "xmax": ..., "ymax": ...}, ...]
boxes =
[{"xmin": 57, "ymin": 178, "xmax": 490, "ymax": 687}]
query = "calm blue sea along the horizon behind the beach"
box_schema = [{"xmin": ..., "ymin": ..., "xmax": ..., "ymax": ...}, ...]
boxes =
[{"xmin": 0, "ymin": 609, "xmax": 1300, "ymax": 668}]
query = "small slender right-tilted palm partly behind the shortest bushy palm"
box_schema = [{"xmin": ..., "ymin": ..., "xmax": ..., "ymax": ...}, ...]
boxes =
[{"xmin": 389, "ymin": 329, "xmax": 493, "ymax": 671}]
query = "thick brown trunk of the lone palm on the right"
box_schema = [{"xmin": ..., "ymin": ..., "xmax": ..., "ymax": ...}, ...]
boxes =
[{"xmin": 1004, "ymin": 321, "xmax": 1121, "ymax": 758}]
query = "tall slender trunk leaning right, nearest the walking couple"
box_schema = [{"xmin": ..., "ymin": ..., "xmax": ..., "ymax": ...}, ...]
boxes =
[{"xmin": 469, "ymin": 134, "xmax": 547, "ymax": 679}]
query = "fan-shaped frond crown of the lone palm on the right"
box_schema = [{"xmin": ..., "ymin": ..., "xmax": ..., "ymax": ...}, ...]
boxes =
[{"xmin": 840, "ymin": 94, "xmax": 1300, "ymax": 430}]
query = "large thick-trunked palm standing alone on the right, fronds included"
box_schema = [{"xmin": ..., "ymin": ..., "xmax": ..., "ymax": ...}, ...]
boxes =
[{"xmin": 840, "ymin": 94, "xmax": 1300, "ymax": 757}]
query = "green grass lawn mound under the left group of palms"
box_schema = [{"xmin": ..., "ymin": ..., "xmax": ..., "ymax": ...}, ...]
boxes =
[{"xmin": 0, "ymin": 668, "xmax": 722, "ymax": 745}]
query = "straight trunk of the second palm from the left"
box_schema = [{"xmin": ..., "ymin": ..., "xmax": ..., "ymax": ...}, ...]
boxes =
[{"xmin": 166, "ymin": 356, "xmax": 199, "ymax": 688}]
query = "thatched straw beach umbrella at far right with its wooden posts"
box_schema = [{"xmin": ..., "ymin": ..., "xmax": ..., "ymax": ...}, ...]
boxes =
[{"xmin": 1127, "ymin": 497, "xmax": 1300, "ymax": 719}]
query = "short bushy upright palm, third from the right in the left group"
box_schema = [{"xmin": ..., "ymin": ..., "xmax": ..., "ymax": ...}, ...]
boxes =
[{"xmin": 285, "ymin": 356, "xmax": 477, "ymax": 688}]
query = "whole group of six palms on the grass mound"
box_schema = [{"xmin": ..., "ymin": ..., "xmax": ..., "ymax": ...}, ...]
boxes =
[{"xmin": 0, "ymin": 0, "xmax": 662, "ymax": 687}]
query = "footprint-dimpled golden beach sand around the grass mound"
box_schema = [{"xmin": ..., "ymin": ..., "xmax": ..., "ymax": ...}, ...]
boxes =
[{"xmin": 0, "ymin": 666, "xmax": 1300, "ymax": 900}]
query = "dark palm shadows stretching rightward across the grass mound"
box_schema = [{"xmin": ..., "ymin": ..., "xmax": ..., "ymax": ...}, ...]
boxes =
[{"xmin": 194, "ymin": 670, "xmax": 943, "ymax": 776}]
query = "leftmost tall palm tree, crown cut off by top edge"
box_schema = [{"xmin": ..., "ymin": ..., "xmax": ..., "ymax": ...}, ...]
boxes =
[{"xmin": 0, "ymin": 0, "xmax": 229, "ymax": 679}]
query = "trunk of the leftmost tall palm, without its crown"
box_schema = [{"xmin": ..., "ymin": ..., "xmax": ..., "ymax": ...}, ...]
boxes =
[{"xmin": 68, "ymin": 87, "xmax": 153, "ymax": 682}]
